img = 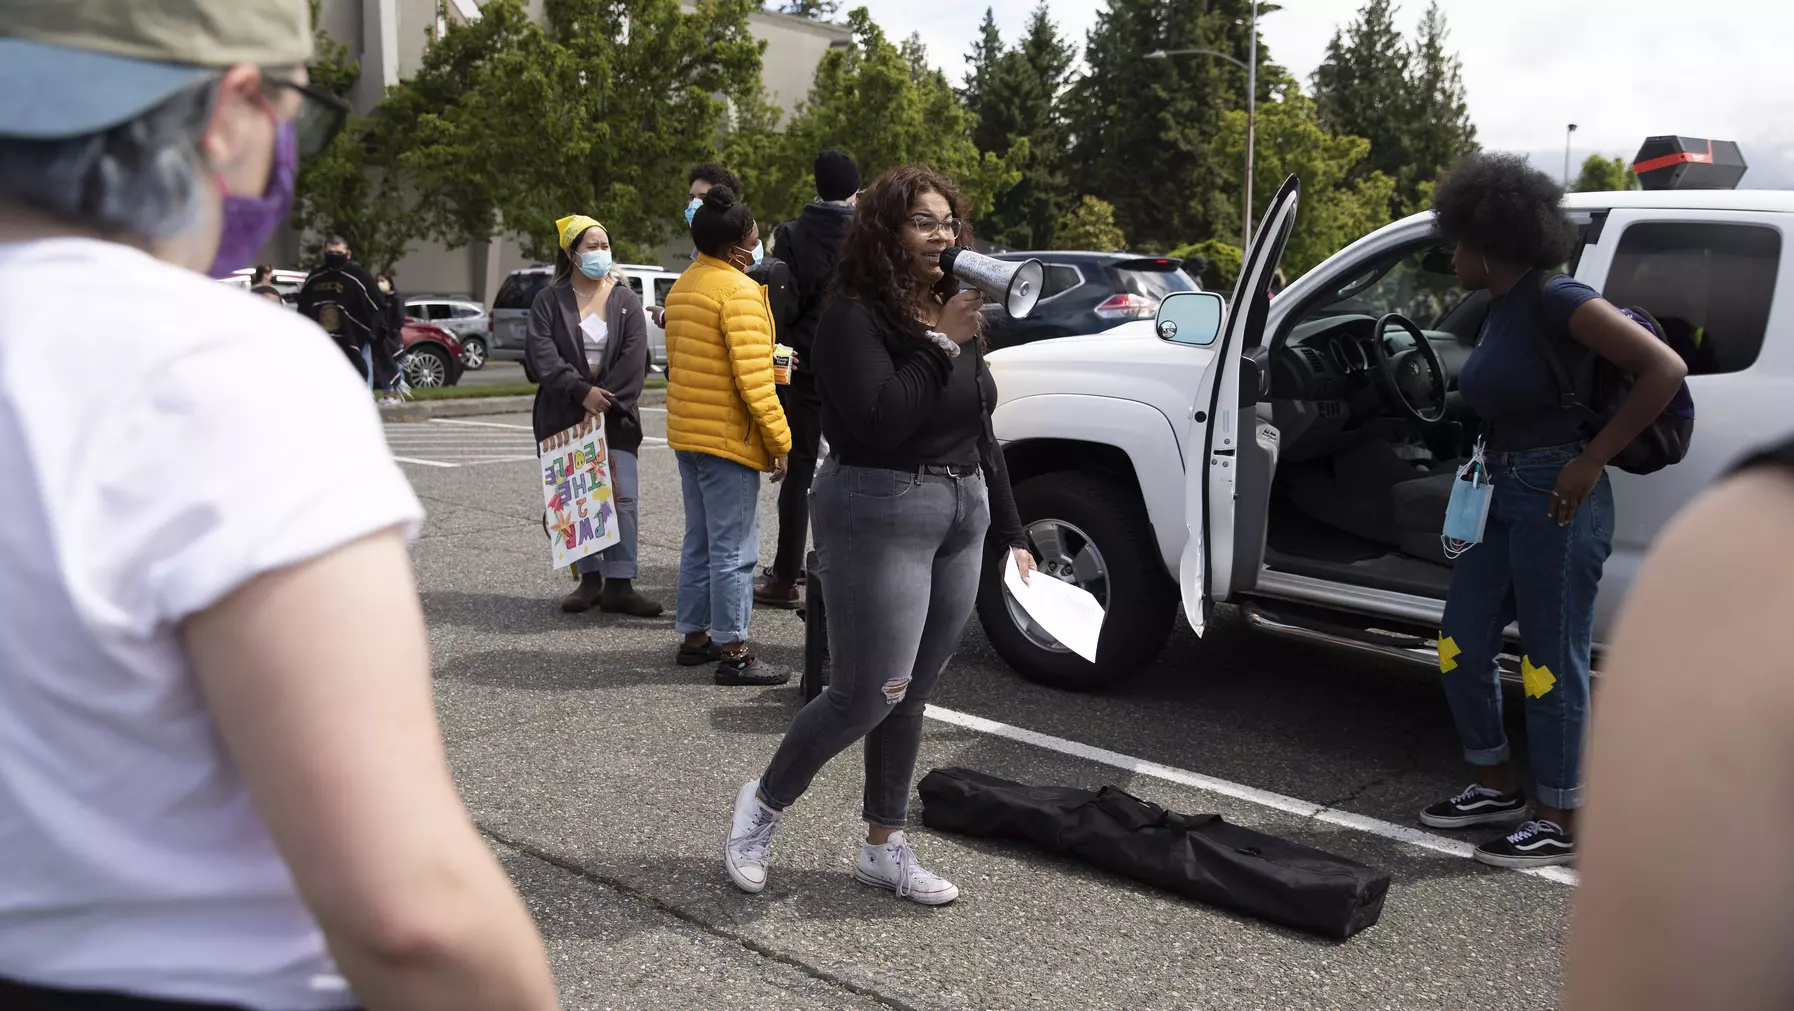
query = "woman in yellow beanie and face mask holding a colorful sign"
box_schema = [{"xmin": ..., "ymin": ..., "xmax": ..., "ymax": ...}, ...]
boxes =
[{"xmin": 524, "ymin": 215, "xmax": 662, "ymax": 618}]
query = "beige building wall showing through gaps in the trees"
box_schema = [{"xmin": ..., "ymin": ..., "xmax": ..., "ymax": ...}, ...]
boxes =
[{"xmin": 294, "ymin": 0, "xmax": 852, "ymax": 305}]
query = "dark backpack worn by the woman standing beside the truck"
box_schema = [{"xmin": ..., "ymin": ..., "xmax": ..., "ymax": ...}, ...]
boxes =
[{"xmin": 1532, "ymin": 272, "xmax": 1694, "ymax": 473}]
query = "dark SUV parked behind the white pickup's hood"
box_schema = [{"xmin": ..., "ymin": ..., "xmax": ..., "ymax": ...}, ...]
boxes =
[{"xmin": 985, "ymin": 251, "xmax": 1202, "ymax": 348}]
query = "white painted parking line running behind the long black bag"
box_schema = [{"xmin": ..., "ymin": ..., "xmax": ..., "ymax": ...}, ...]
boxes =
[{"xmin": 926, "ymin": 706, "xmax": 1577, "ymax": 886}]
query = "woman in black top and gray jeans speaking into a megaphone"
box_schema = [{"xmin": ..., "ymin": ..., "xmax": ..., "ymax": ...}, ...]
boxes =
[{"xmin": 725, "ymin": 167, "xmax": 1033, "ymax": 905}]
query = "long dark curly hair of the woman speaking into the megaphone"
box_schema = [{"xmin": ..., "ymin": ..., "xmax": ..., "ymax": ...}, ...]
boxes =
[{"xmin": 832, "ymin": 165, "xmax": 972, "ymax": 321}]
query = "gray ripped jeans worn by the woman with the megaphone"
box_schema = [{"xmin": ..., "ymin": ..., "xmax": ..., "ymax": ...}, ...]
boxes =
[{"xmin": 761, "ymin": 459, "xmax": 990, "ymax": 828}]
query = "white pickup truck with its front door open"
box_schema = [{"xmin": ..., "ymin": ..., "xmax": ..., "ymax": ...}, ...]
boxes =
[{"xmin": 978, "ymin": 177, "xmax": 1794, "ymax": 688}]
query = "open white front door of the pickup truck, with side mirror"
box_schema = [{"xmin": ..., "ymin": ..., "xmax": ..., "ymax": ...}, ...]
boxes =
[{"xmin": 1157, "ymin": 176, "xmax": 1301, "ymax": 635}]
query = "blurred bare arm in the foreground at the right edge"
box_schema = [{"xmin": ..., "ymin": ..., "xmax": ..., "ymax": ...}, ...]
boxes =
[{"xmin": 1566, "ymin": 470, "xmax": 1794, "ymax": 1011}]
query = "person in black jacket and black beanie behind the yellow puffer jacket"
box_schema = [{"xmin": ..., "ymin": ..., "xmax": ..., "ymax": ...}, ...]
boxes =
[{"xmin": 753, "ymin": 151, "xmax": 859, "ymax": 608}]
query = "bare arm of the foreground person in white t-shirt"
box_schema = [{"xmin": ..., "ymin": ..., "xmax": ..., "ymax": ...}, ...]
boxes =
[{"xmin": 183, "ymin": 532, "xmax": 558, "ymax": 1011}]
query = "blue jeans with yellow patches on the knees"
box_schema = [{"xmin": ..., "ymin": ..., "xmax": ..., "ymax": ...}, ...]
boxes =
[{"xmin": 1439, "ymin": 445, "xmax": 1613, "ymax": 810}]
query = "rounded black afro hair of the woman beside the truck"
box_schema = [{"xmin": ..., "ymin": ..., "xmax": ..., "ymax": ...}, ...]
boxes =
[{"xmin": 1433, "ymin": 154, "xmax": 1575, "ymax": 267}]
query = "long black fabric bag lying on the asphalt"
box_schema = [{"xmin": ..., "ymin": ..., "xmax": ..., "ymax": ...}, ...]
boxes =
[{"xmin": 919, "ymin": 769, "xmax": 1389, "ymax": 939}]
